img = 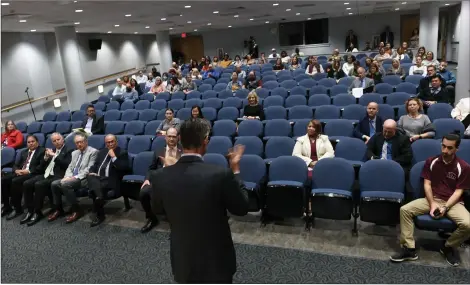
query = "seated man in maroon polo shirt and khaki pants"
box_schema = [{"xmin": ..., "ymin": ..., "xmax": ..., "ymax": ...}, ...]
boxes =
[{"xmin": 390, "ymin": 134, "xmax": 470, "ymax": 266}]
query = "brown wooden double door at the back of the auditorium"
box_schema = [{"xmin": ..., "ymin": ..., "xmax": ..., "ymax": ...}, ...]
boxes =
[{"xmin": 171, "ymin": 36, "xmax": 204, "ymax": 62}]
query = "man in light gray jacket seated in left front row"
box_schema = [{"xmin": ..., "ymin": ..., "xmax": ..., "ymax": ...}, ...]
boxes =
[{"xmin": 48, "ymin": 133, "xmax": 98, "ymax": 223}]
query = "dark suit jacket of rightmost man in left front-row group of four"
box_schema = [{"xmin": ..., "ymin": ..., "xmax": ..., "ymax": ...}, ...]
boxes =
[{"xmin": 90, "ymin": 147, "xmax": 129, "ymax": 191}]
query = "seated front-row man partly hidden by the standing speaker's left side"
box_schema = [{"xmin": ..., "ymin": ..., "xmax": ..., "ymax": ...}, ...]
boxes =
[{"xmin": 139, "ymin": 128, "xmax": 183, "ymax": 233}]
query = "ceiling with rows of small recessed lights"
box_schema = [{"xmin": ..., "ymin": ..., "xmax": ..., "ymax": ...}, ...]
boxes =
[{"xmin": 1, "ymin": 0, "xmax": 459, "ymax": 34}]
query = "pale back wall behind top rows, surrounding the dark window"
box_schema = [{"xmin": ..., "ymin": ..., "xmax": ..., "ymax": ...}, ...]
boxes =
[{"xmin": 201, "ymin": 11, "xmax": 418, "ymax": 57}]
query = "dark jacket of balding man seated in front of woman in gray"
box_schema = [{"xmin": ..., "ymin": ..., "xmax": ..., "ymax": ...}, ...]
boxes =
[{"xmin": 367, "ymin": 131, "xmax": 413, "ymax": 169}]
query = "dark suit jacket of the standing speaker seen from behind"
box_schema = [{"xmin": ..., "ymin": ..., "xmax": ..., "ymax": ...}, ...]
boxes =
[{"xmin": 150, "ymin": 155, "xmax": 248, "ymax": 283}]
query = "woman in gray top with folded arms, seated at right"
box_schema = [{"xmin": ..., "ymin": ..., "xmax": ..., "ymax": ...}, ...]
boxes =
[{"xmin": 398, "ymin": 98, "xmax": 436, "ymax": 142}]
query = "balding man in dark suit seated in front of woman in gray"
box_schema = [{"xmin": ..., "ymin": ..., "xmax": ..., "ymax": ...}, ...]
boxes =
[{"xmin": 367, "ymin": 119, "xmax": 413, "ymax": 170}]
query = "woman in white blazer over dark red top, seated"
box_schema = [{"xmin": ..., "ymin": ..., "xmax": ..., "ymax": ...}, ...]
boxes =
[{"xmin": 292, "ymin": 117, "xmax": 335, "ymax": 168}]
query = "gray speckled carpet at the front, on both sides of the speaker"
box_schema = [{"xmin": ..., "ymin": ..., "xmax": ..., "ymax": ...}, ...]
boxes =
[{"xmin": 1, "ymin": 220, "xmax": 470, "ymax": 284}]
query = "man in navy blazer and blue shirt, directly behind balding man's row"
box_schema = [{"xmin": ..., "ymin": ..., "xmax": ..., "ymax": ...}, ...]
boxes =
[{"xmin": 354, "ymin": 102, "xmax": 384, "ymax": 143}]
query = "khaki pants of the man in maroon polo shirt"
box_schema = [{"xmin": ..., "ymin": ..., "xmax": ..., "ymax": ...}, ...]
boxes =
[{"xmin": 400, "ymin": 198, "xmax": 470, "ymax": 248}]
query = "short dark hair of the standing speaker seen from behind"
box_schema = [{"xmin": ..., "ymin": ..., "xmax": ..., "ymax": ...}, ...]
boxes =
[{"xmin": 180, "ymin": 118, "xmax": 210, "ymax": 149}]
